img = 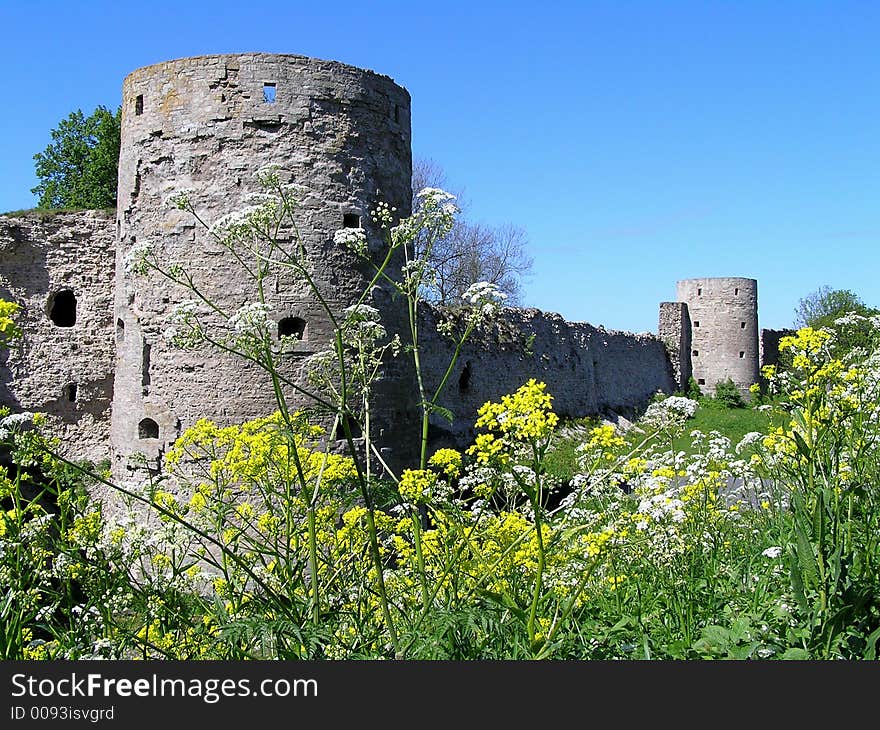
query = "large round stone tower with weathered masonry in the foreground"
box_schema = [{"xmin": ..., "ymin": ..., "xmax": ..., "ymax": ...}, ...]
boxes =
[{"xmin": 111, "ymin": 53, "xmax": 412, "ymax": 472}]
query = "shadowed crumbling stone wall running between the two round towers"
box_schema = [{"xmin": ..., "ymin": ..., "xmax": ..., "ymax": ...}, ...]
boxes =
[{"xmin": 420, "ymin": 307, "xmax": 676, "ymax": 448}]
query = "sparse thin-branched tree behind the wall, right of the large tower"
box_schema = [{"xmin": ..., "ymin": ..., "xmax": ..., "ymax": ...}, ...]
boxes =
[{"xmin": 412, "ymin": 159, "xmax": 533, "ymax": 305}]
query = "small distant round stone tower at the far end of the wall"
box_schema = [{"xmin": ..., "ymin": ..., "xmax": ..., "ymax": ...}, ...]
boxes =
[{"xmin": 677, "ymin": 277, "xmax": 759, "ymax": 395}]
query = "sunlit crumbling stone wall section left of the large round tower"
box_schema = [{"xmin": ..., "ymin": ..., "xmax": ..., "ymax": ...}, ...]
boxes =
[{"xmin": 0, "ymin": 211, "xmax": 115, "ymax": 462}]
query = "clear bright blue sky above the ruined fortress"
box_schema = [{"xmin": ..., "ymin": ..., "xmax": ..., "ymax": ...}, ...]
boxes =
[{"xmin": 0, "ymin": 0, "xmax": 880, "ymax": 332}]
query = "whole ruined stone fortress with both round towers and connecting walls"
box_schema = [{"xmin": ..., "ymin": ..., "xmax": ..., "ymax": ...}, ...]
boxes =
[{"xmin": 0, "ymin": 54, "xmax": 784, "ymax": 474}]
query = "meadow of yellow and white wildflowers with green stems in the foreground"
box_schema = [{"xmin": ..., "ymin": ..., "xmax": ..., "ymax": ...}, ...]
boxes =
[{"xmin": 0, "ymin": 170, "xmax": 880, "ymax": 660}]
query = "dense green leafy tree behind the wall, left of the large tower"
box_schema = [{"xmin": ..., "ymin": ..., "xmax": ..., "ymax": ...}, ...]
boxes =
[{"xmin": 31, "ymin": 106, "xmax": 122, "ymax": 209}]
